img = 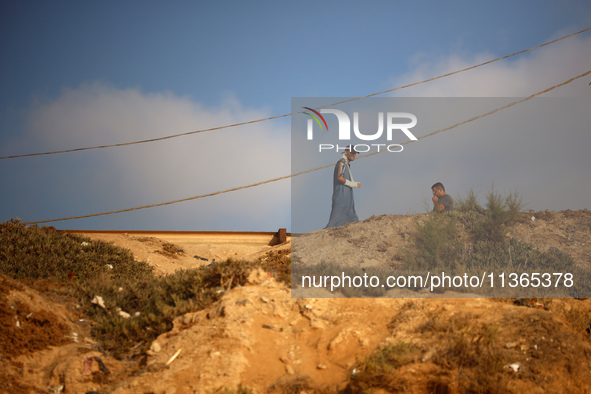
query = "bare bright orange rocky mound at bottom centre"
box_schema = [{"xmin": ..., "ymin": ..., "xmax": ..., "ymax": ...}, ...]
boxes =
[{"xmin": 116, "ymin": 270, "xmax": 398, "ymax": 393}]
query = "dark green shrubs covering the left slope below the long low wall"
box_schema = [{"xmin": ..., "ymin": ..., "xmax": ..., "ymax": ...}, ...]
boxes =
[{"xmin": 0, "ymin": 220, "xmax": 291, "ymax": 359}]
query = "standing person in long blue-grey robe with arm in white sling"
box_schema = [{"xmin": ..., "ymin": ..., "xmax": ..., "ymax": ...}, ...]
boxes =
[{"xmin": 325, "ymin": 145, "xmax": 361, "ymax": 228}]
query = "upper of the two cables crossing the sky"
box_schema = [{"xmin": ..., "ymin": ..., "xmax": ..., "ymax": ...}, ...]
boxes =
[{"xmin": 0, "ymin": 27, "xmax": 591, "ymax": 160}]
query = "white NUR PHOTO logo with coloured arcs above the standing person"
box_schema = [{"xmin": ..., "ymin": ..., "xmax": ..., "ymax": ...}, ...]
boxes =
[{"xmin": 303, "ymin": 107, "xmax": 418, "ymax": 153}]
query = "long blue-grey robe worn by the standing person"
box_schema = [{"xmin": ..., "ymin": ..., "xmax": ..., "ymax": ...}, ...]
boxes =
[{"xmin": 325, "ymin": 156, "xmax": 359, "ymax": 228}]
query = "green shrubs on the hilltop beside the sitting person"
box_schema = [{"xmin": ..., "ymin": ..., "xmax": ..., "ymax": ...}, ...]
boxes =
[{"xmin": 403, "ymin": 186, "xmax": 591, "ymax": 297}]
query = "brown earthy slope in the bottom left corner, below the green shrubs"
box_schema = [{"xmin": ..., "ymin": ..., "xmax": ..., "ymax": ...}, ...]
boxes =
[{"xmin": 0, "ymin": 278, "xmax": 126, "ymax": 393}]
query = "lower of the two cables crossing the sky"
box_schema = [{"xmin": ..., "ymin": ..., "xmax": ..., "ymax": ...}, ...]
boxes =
[{"xmin": 23, "ymin": 70, "xmax": 591, "ymax": 224}]
